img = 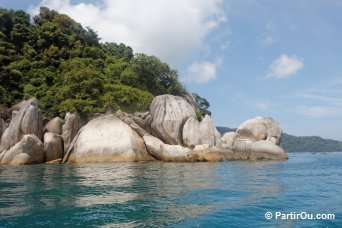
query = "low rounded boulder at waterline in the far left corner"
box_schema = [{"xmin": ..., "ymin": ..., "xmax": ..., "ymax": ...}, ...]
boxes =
[{"xmin": 0, "ymin": 134, "xmax": 45, "ymax": 165}]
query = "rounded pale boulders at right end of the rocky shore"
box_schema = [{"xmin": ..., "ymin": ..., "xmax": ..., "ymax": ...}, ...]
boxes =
[{"xmin": 233, "ymin": 117, "xmax": 288, "ymax": 160}]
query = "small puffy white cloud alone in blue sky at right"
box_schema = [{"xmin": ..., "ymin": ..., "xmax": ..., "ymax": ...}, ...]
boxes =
[{"xmin": 267, "ymin": 54, "xmax": 304, "ymax": 79}]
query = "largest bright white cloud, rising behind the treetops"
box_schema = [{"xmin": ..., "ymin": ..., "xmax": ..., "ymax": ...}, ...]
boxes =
[{"xmin": 30, "ymin": 0, "xmax": 226, "ymax": 64}]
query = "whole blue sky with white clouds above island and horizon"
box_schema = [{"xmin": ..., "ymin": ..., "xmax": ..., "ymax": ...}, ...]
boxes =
[{"xmin": 0, "ymin": 0, "xmax": 342, "ymax": 140}]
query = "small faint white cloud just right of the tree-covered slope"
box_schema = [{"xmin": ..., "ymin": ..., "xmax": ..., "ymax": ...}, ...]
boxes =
[{"xmin": 184, "ymin": 60, "xmax": 221, "ymax": 84}]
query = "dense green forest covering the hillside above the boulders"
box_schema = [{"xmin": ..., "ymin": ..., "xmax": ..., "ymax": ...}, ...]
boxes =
[{"xmin": 0, "ymin": 7, "xmax": 194, "ymax": 117}]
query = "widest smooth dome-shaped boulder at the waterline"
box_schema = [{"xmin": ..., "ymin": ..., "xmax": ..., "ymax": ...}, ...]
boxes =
[{"xmin": 63, "ymin": 114, "xmax": 153, "ymax": 163}]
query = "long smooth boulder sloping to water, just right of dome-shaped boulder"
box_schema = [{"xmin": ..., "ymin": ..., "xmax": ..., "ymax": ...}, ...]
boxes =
[{"xmin": 143, "ymin": 135, "xmax": 194, "ymax": 162}]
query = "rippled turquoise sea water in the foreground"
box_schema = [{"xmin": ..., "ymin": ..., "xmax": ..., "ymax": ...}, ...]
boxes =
[{"xmin": 0, "ymin": 153, "xmax": 342, "ymax": 227}]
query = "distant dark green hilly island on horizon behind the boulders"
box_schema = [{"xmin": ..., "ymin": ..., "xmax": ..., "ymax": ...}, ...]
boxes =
[{"xmin": 217, "ymin": 127, "xmax": 342, "ymax": 152}]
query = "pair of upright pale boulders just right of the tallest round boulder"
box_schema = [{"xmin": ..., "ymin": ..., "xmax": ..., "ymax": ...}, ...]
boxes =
[{"xmin": 182, "ymin": 115, "xmax": 222, "ymax": 148}]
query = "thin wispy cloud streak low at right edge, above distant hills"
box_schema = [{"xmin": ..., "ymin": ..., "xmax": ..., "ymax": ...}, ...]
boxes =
[{"xmin": 295, "ymin": 105, "xmax": 340, "ymax": 118}]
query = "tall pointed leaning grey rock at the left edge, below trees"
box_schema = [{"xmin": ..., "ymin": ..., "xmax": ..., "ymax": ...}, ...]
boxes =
[{"xmin": 0, "ymin": 98, "xmax": 43, "ymax": 151}]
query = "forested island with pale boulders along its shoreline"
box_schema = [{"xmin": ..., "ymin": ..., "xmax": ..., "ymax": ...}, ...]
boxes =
[{"xmin": 0, "ymin": 7, "xmax": 326, "ymax": 164}]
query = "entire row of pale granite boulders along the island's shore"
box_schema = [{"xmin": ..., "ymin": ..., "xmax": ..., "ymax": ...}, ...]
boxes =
[{"xmin": 0, "ymin": 95, "xmax": 287, "ymax": 165}]
